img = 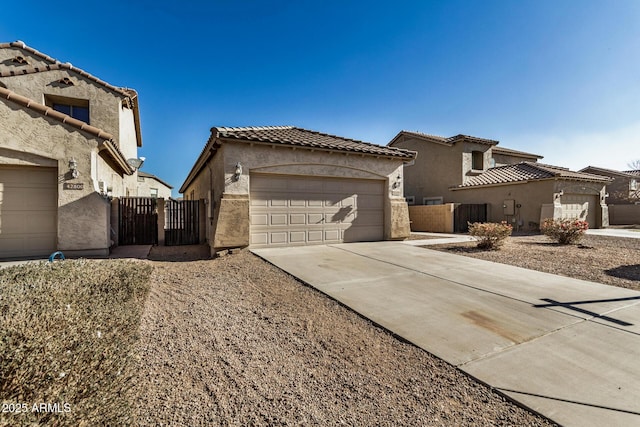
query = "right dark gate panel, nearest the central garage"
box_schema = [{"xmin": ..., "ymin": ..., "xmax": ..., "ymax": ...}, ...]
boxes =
[{"xmin": 164, "ymin": 199, "xmax": 200, "ymax": 246}]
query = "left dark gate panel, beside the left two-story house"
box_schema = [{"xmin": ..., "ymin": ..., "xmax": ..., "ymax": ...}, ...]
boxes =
[{"xmin": 118, "ymin": 197, "xmax": 158, "ymax": 245}]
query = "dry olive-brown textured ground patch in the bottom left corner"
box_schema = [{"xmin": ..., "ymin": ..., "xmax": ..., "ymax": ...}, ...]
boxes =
[{"xmin": 0, "ymin": 260, "xmax": 151, "ymax": 426}]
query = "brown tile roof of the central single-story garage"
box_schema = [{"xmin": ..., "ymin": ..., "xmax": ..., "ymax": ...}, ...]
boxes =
[{"xmin": 211, "ymin": 126, "xmax": 416, "ymax": 160}]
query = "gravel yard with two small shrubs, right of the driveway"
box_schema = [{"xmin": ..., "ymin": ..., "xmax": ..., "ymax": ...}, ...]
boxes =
[{"xmin": 425, "ymin": 234, "xmax": 640, "ymax": 290}]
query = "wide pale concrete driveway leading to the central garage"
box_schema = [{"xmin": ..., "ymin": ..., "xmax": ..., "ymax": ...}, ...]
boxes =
[{"xmin": 253, "ymin": 242, "xmax": 640, "ymax": 426}]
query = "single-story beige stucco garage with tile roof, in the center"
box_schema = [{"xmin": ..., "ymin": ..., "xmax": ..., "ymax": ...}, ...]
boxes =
[{"xmin": 180, "ymin": 126, "xmax": 415, "ymax": 252}]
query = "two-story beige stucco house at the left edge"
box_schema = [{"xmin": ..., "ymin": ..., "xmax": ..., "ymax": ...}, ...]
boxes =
[{"xmin": 0, "ymin": 42, "xmax": 154, "ymax": 258}]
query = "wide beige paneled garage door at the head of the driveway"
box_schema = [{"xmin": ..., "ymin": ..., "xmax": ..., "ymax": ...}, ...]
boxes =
[{"xmin": 250, "ymin": 174, "xmax": 384, "ymax": 247}]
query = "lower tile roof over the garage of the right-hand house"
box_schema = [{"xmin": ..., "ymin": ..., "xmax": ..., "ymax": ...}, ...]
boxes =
[{"xmin": 457, "ymin": 162, "xmax": 611, "ymax": 188}]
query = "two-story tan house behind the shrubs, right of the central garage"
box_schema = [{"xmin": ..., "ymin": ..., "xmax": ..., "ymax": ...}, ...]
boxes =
[{"xmin": 388, "ymin": 131, "xmax": 609, "ymax": 230}]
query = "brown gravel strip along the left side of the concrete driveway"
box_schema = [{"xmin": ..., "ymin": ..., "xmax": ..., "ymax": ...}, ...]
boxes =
[{"xmin": 132, "ymin": 247, "xmax": 550, "ymax": 426}]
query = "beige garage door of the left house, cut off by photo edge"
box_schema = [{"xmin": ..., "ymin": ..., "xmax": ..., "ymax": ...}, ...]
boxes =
[{"xmin": 0, "ymin": 166, "xmax": 58, "ymax": 258}]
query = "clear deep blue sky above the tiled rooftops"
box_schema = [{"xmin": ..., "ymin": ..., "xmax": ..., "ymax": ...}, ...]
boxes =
[{"xmin": 0, "ymin": 0, "xmax": 640, "ymax": 195}]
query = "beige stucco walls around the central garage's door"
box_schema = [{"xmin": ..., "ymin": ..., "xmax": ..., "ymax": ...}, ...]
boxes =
[{"xmin": 184, "ymin": 142, "xmax": 409, "ymax": 254}]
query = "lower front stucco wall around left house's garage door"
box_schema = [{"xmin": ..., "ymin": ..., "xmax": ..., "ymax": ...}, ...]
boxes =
[{"xmin": 0, "ymin": 100, "xmax": 117, "ymax": 255}]
